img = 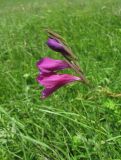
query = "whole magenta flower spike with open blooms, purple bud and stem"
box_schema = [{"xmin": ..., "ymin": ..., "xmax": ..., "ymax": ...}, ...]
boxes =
[{"xmin": 37, "ymin": 30, "xmax": 88, "ymax": 99}]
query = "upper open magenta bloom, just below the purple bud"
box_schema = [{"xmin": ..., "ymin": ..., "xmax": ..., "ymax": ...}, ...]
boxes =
[{"xmin": 37, "ymin": 57, "xmax": 70, "ymax": 74}]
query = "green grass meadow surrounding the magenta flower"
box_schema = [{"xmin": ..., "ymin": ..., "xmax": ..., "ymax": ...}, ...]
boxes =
[{"xmin": 0, "ymin": 0, "xmax": 121, "ymax": 160}]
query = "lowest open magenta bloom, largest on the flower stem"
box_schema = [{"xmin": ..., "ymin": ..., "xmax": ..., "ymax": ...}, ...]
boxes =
[{"xmin": 37, "ymin": 73, "xmax": 81, "ymax": 98}]
